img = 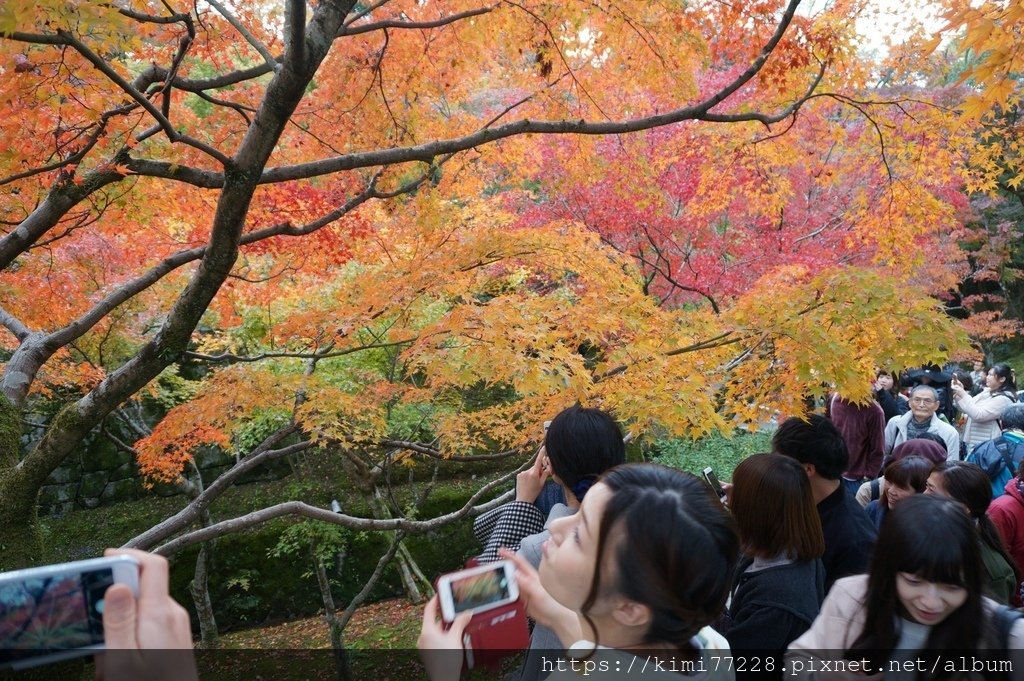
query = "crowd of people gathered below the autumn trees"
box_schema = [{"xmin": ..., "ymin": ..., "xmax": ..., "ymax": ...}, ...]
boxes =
[{"xmin": 90, "ymin": 365, "xmax": 1024, "ymax": 681}]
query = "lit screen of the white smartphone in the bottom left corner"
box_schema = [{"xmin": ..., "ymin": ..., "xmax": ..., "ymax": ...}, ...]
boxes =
[{"xmin": 0, "ymin": 567, "xmax": 114, "ymax": 666}]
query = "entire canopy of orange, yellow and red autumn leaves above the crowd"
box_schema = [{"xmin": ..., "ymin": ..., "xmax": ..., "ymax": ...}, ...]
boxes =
[{"xmin": 0, "ymin": 0, "xmax": 1007, "ymax": 522}]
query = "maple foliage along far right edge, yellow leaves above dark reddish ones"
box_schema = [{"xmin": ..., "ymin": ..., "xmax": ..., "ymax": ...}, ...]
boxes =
[{"xmin": 904, "ymin": 0, "xmax": 1024, "ymax": 357}]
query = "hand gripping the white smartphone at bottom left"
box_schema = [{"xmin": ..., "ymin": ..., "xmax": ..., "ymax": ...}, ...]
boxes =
[{"xmin": 96, "ymin": 549, "xmax": 198, "ymax": 681}]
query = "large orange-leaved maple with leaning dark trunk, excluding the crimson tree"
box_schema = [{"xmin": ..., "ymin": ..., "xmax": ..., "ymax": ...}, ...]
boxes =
[{"xmin": 0, "ymin": 0, "xmax": 974, "ymax": 564}]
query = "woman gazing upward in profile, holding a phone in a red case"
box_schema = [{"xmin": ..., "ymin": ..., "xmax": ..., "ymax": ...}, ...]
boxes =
[{"xmin": 419, "ymin": 464, "xmax": 738, "ymax": 681}]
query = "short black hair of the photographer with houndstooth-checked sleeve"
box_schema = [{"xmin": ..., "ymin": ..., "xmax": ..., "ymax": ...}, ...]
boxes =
[{"xmin": 544, "ymin": 405, "xmax": 626, "ymax": 501}]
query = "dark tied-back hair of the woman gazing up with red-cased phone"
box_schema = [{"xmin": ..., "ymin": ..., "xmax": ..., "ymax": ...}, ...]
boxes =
[{"xmin": 581, "ymin": 464, "xmax": 739, "ymax": 650}]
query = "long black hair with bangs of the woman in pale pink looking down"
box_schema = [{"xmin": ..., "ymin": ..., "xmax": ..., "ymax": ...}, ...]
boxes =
[{"xmin": 847, "ymin": 495, "xmax": 984, "ymax": 679}]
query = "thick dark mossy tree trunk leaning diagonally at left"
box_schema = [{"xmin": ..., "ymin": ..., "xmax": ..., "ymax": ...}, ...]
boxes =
[{"xmin": 0, "ymin": 0, "xmax": 355, "ymax": 564}]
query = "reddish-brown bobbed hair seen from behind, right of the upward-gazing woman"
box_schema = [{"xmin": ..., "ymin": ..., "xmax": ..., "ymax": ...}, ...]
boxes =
[{"xmin": 729, "ymin": 454, "xmax": 825, "ymax": 561}]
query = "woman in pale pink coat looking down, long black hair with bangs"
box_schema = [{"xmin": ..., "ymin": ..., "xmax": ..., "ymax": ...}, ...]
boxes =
[{"xmin": 785, "ymin": 495, "xmax": 1024, "ymax": 681}]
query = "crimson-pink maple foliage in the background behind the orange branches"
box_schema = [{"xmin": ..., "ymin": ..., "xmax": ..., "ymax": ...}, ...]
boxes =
[{"xmin": 514, "ymin": 92, "xmax": 969, "ymax": 309}]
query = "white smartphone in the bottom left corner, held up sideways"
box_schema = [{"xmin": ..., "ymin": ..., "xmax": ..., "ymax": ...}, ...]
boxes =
[{"xmin": 0, "ymin": 556, "xmax": 138, "ymax": 670}]
